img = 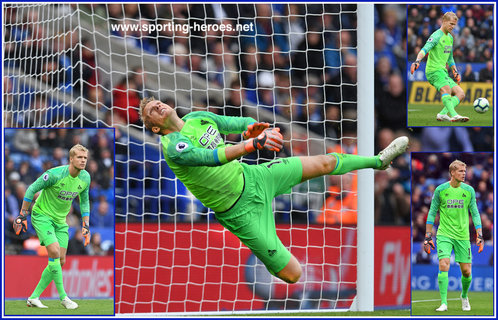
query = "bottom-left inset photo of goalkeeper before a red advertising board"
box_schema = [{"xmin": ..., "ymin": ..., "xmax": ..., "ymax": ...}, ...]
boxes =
[{"xmin": 3, "ymin": 128, "xmax": 115, "ymax": 317}]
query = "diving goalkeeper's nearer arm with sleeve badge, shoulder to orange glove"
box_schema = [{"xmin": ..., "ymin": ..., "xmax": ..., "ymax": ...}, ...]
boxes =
[{"xmin": 169, "ymin": 128, "xmax": 283, "ymax": 167}]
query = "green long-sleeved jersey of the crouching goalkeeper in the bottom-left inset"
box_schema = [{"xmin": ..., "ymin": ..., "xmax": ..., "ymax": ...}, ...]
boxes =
[{"xmin": 24, "ymin": 165, "xmax": 90, "ymax": 224}]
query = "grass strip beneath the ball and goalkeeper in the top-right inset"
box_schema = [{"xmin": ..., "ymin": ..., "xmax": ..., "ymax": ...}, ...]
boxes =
[{"xmin": 408, "ymin": 104, "xmax": 493, "ymax": 127}]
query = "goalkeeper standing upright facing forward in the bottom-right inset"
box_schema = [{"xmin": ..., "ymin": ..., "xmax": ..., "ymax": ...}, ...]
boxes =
[{"xmin": 424, "ymin": 160, "xmax": 484, "ymax": 311}]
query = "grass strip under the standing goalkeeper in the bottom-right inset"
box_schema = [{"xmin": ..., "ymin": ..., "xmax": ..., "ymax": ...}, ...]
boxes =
[{"xmin": 412, "ymin": 290, "xmax": 494, "ymax": 316}]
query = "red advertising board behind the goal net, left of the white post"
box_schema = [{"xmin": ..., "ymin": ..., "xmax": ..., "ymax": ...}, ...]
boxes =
[{"xmin": 116, "ymin": 223, "xmax": 356, "ymax": 313}]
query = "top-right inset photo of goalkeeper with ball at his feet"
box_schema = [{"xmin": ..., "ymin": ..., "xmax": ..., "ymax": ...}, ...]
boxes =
[{"xmin": 406, "ymin": 3, "xmax": 495, "ymax": 127}]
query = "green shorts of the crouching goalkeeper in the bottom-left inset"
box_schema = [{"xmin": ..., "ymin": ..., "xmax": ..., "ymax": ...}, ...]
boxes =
[{"xmin": 31, "ymin": 212, "xmax": 69, "ymax": 248}]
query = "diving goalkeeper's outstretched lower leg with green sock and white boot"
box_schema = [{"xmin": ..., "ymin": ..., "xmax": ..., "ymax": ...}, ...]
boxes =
[{"xmin": 300, "ymin": 136, "xmax": 408, "ymax": 182}]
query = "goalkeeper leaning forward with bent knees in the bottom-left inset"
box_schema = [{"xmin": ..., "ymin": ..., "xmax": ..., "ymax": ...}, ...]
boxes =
[{"xmin": 14, "ymin": 144, "xmax": 90, "ymax": 309}]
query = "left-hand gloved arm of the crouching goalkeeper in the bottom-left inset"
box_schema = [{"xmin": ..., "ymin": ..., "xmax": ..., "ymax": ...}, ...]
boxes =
[{"xmin": 12, "ymin": 171, "xmax": 57, "ymax": 235}]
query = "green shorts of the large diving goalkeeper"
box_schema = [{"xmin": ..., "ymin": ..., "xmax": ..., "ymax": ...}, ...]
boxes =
[{"xmin": 216, "ymin": 157, "xmax": 303, "ymax": 275}]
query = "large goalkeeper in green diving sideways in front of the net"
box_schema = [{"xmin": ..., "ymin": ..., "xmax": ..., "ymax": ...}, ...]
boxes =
[{"xmin": 140, "ymin": 98, "xmax": 408, "ymax": 283}]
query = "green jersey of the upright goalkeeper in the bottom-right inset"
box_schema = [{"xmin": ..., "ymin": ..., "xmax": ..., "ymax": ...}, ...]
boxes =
[{"xmin": 427, "ymin": 182, "xmax": 481, "ymax": 240}]
